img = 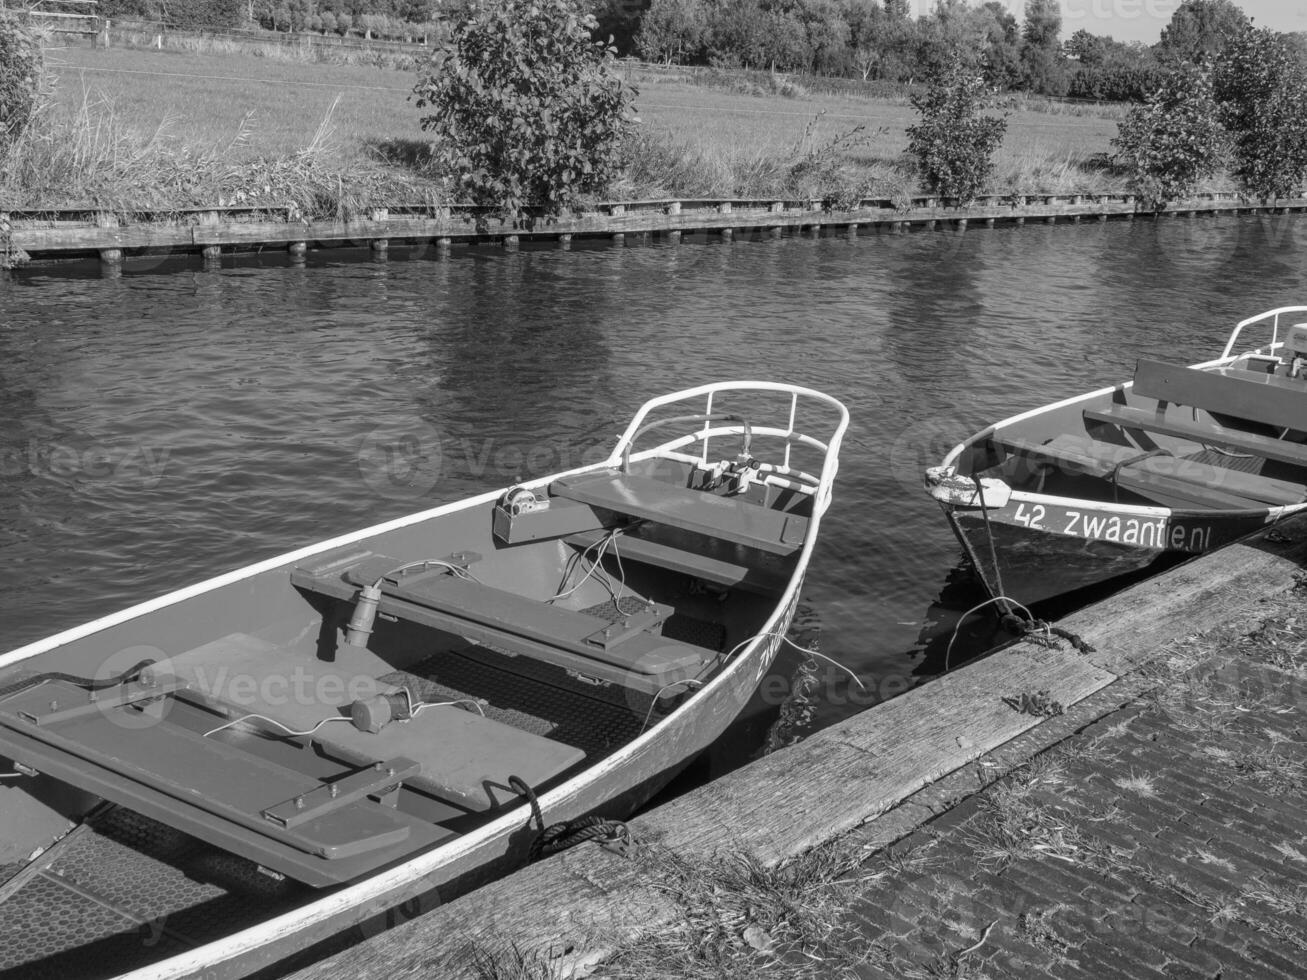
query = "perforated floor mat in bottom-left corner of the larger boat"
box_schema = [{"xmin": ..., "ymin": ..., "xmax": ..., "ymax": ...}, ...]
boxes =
[{"xmin": 0, "ymin": 808, "xmax": 303, "ymax": 980}]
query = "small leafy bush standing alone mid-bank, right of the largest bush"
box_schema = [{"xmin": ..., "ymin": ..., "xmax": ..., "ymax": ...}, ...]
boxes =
[{"xmin": 907, "ymin": 61, "xmax": 1008, "ymax": 206}]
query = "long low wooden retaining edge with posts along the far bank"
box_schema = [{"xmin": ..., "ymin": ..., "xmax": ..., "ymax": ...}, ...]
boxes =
[{"xmin": 0, "ymin": 193, "xmax": 1307, "ymax": 273}]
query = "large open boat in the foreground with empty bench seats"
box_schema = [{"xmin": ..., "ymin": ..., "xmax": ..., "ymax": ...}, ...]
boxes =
[{"xmin": 0, "ymin": 382, "xmax": 848, "ymax": 980}]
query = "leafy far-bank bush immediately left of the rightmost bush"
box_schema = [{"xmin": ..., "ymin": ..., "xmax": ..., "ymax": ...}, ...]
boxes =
[{"xmin": 1112, "ymin": 64, "xmax": 1225, "ymax": 208}]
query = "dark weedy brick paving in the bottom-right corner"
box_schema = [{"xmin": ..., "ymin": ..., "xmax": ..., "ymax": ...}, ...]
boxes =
[{"xmin": 805, "ymin": 621, "xmax": 1307, "ymax": 980}]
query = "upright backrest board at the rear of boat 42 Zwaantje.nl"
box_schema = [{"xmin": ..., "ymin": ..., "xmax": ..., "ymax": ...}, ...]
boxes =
[{"xmin": 1133, "ymin": 358, "xmax": 1307, "ymax": 429}]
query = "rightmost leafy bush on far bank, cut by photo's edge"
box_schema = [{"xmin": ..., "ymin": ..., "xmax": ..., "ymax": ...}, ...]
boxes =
[{"xmin": 1213, "ymin": 26, "xmax": 1307, "ymax": 200}]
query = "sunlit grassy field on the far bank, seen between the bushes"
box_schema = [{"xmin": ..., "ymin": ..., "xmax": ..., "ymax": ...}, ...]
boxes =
[{"xmin": 0, "ymin": 46, "xmax": 1223, "ymax": 214}]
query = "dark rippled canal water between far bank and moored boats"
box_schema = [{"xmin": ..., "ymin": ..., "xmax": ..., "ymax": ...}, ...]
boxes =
[{"xmin": 0, "ymin": 216, "xmax": 1307, "ymax": 728}]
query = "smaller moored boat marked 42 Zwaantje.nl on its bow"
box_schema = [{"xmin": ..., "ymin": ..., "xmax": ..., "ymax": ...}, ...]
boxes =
[{"xmin": 925, "ymin": 306, "xmax": 1307, "ymax": 604}]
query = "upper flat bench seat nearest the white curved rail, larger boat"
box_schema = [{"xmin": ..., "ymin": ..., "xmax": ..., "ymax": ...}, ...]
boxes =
[{"xmin": 549, "ymin": 470, "xmax": 808, "ymax": 555}]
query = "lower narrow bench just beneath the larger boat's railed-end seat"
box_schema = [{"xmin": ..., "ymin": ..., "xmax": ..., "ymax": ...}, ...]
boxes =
[{"xmin": 563, "ymin": 525, "xmax": 793, "ymax": 596}]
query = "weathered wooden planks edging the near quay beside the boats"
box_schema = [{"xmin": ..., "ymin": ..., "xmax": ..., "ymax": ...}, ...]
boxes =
[{"xmin": 289, "ymin": 517, "xmax": 1307, "ymax": 980}]
